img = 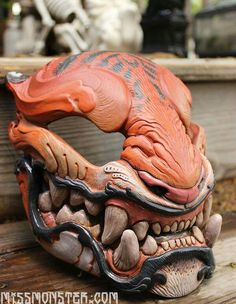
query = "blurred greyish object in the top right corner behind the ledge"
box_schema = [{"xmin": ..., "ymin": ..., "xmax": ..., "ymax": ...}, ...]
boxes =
[{"xmin": 193, "ymin": 0, "xmax": 236, "ymax": 57}]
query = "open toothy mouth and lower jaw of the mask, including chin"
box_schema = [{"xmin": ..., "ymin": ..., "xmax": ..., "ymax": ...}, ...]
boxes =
[{"xmin": 17, "ymin": 159, "xmax": 221, "ymax": 296}]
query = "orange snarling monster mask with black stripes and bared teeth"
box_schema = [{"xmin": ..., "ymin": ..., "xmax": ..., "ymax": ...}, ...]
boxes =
[{"xmin": 8, "ymin": 52, "xmax": 221, "ymax": 297}]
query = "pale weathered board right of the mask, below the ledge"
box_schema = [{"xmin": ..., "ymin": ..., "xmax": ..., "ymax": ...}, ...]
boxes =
[{"xmin": 191, "ymin": 82, "xmax": 236, "ymax": 180}]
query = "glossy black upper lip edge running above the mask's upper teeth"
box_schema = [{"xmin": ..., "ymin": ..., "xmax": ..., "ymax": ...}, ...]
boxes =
[{"xmin": 49, "ymin": 173, "xmax": 214, "ymax": 216}]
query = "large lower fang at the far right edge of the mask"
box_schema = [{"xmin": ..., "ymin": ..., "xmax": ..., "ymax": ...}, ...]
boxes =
[{"xmin": 203, "ymin": 214, "xmax": 222, "ymax": 247}]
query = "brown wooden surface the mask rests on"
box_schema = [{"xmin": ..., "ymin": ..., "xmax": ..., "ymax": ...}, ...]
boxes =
[{"xmin": 0, "ymin": 213, "xmax": 236, "ymax": 304}]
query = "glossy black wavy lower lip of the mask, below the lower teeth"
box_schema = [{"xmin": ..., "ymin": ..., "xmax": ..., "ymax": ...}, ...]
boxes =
[{"xmin": 16, "ymin": 158, "xmax": 215, "ymax": 293}]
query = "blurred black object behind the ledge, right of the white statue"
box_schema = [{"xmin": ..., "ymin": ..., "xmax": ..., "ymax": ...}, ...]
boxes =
[{"xmin": 141, "ymin": 0, "xmax": 188, "ymax": 57}]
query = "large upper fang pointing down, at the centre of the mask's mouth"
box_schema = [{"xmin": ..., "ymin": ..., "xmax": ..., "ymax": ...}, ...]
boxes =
[{"xmin": 102, "ymin": 206, "xmax": 128, "ymax": 245}]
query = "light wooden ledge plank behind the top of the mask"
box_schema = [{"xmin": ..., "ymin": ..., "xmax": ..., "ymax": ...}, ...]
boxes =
[{"xmin": 0, "ymin": 54, "xmax": 236, "ymax": 82}]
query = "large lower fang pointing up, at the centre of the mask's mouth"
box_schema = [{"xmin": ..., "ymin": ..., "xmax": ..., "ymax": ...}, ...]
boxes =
[{"xmin": 113, "ymin": 229, "xmax": 140, "ymax": 271}]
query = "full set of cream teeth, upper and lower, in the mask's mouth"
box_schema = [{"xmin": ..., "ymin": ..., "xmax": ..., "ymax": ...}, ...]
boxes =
[{"xmin": 38, "ymin": 179, "xmax": 216, "ymax": 271}]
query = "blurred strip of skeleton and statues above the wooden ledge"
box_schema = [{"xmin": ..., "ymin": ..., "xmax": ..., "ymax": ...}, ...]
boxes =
[{"xmin": 0, "ymin": 0, "xmax": 236, "ymax": 58}]
